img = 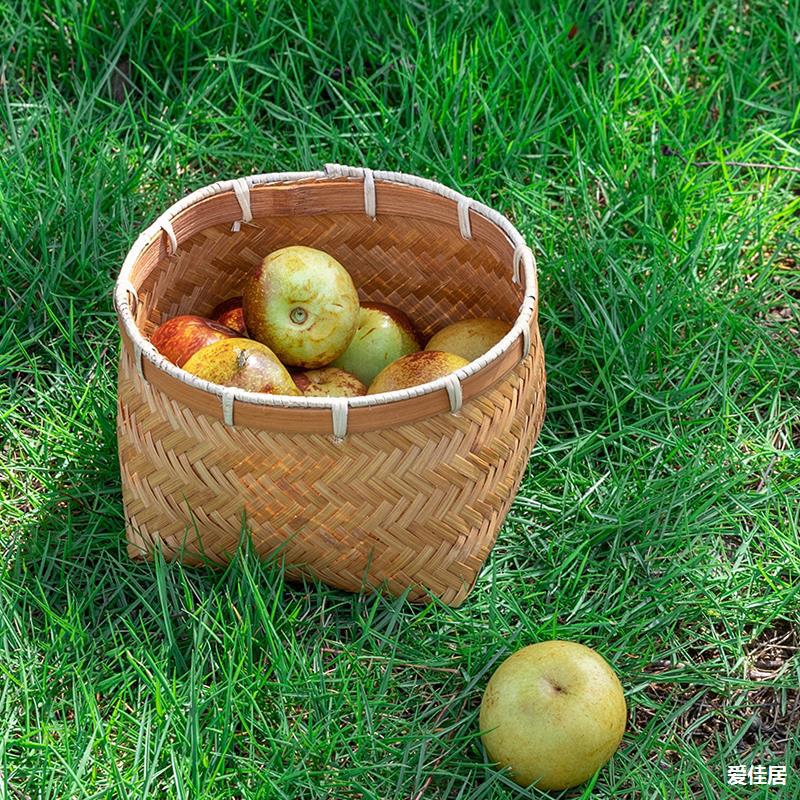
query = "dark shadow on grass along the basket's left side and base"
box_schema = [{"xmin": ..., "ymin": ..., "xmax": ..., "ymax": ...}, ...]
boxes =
[{"xmin": 3, "ymin": 412, "xmax": 432, "ymax": 673}]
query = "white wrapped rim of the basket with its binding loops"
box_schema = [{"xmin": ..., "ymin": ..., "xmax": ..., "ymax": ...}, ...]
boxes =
[{"xmin": 113, "ymin": 164, "xmax": 538, "ymax": 424}]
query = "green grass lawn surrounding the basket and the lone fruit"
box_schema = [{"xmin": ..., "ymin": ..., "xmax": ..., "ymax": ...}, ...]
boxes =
[{"xmin": 0, "ymin": 0, "xmax": 800, "ymax": 800}]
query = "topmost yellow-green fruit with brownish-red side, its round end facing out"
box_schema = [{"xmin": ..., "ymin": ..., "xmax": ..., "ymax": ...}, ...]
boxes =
[{"xmin": 242, "ymin": 245, "xmax": 359, "ymax": 369}]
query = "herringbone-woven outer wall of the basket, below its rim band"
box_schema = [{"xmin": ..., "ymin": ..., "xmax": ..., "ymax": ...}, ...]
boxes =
[{"xmin": 118, "ymin": 328, "xmax": 544, "ymax": 605}]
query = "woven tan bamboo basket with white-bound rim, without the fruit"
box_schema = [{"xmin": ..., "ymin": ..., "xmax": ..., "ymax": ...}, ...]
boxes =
[{"xmin": 114, "ymin": 164, "xmax": 545, "ymax": 605}]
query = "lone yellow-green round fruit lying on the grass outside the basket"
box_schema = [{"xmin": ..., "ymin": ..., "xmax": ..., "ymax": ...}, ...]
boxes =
[{"xmin": 480, "ymin": 640, "xmax": 626, "ymax": 791}]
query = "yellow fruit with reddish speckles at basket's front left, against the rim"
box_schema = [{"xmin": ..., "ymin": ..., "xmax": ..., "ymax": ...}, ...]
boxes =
[{"xmin": 183, "ymin": 338, "xmax": 301, "ymax": 397}]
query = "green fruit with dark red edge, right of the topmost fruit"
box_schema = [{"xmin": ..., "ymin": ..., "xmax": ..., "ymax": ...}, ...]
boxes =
[{"xmin": 333, "ymin": 303, "xmax": 422, "ymax": 385}]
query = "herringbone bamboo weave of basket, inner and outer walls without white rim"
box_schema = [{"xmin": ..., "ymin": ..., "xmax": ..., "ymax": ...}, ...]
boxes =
[{"xmin": 117, "ymin": 170, "xmax": 545, "ymax": 605}]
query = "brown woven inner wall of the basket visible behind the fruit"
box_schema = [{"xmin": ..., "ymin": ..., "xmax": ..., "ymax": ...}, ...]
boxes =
[{"xmin": 132, "ymin": 181, "xmax": 522, "ymax": 339}]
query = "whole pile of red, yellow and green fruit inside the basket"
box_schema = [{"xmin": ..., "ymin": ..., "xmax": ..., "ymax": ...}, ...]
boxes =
[{"xmin": 151, "ymin": 245, "xmax": 511, "ymax": 397}]
